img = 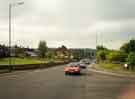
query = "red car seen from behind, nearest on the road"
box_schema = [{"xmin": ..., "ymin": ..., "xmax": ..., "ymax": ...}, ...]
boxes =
[{"xmin": 64, "ymin": 64, "xmax": 81, "ymax": 74}]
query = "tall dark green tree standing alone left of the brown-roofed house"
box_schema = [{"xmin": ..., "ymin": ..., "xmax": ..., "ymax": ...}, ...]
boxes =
[{"xmin": 38, "ymin": 41, "xmax": 47, "ymax": 58}]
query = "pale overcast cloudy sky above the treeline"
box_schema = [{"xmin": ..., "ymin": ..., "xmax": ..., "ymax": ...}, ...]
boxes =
[{"xmin": 0, "ymin": 0, "xmax": 135, "ymax": 49}]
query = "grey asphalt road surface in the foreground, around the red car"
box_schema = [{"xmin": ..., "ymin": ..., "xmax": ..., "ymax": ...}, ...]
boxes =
[{"xmin": 0, "ymin": 66, "xmax": 134, "ymax": 99}]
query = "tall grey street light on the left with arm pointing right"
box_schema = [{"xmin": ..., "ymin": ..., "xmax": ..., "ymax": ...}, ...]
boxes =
[{"xmin": 9, "ymin": 2, "xmax": 24, "ymax": 71}]
